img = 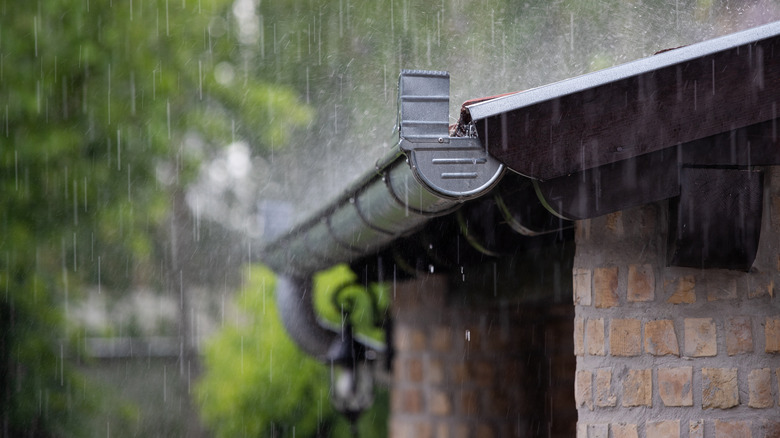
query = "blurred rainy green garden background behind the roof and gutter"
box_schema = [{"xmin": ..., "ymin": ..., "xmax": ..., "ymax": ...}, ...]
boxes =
[{"xmin": 0, "ymin": 0, "xmax": 780, "ymax": 437}]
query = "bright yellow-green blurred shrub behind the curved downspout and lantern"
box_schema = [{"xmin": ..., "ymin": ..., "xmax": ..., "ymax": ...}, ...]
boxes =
[{"xmin": 196, "ymin": 266, "xmax": 387, "ymax": 437}]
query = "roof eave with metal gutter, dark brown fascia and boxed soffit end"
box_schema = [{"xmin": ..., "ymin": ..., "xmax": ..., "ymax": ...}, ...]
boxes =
[{"xmin": 262, "ymin": 23, "xmax": 780, "ymax": 277}]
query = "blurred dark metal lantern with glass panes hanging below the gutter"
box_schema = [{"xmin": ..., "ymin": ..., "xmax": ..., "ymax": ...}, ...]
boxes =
[{"xmin": 328, "ymin": 325, "xmax": 374, "ymax": 428}]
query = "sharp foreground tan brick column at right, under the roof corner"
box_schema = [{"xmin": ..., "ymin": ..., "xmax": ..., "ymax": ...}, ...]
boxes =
[{"xmin": 573, "ymin": 169, "xmax": 780, "ymax": 438}]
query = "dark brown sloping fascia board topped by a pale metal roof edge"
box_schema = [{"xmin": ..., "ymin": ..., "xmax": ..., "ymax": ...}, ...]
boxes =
[{"xmin": 467, "ymin": 22, "xmax": 780, "ymax": 180}]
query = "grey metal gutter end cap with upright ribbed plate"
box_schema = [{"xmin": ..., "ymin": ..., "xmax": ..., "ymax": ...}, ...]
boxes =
[{"xmin": 398, "ymin": 70, "xmax": 504, "ymax": 201}]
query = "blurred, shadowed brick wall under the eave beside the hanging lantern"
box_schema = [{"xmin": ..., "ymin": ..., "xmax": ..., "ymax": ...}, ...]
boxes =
[{"xmin": 390, "ymin": 275, "xmax": 576, "ymax": 438}]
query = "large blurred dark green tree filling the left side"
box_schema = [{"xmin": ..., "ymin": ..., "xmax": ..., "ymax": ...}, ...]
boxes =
[{"xmin": 0, "ymin": 0, "xmax": 310, "ymax": 436}]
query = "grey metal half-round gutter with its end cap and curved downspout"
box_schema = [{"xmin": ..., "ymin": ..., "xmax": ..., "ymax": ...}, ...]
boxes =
[{"xmin": 261, "ymin": 70, "xmax": 504, "ymax": 361}]
